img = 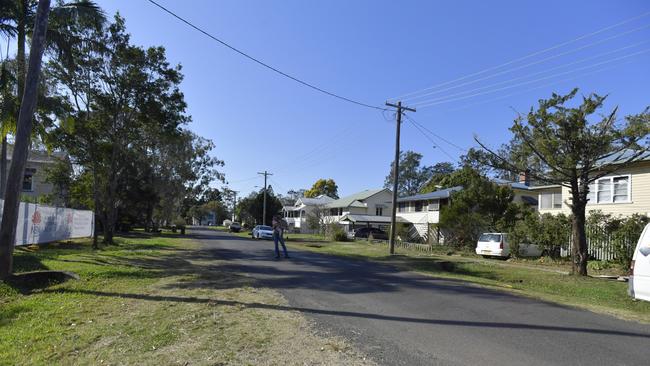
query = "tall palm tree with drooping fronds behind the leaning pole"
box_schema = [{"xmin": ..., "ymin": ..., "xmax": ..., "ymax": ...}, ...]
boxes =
[{"xmin": 0, "ymin": 0, "xmax": 106, "ymax": 198}]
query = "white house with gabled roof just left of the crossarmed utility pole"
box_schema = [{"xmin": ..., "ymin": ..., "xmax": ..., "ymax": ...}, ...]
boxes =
[{"xmin": 324, "ymin": 188, "xmax": 393, "ymax": 231}]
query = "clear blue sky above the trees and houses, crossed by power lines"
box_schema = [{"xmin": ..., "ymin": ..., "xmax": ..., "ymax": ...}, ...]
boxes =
[{"xmin": 93, "ymin": 0, "xmax": 650, "ymax": 195}]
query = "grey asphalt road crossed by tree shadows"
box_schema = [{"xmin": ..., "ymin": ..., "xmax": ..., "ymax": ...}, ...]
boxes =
[{"xmin": 191, "ymin": 229, "xmax": 650, "ymax": 366}]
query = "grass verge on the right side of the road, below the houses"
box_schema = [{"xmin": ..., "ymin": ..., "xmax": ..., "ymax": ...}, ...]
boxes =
[{"xmin": 289, "ymin": 241, "xmax": 650, "ymax": 323}]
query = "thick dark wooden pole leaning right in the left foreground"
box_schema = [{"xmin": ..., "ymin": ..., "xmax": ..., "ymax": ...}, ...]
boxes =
[{"xmin": 0, "ymin": 0, "xmax": 50, "ymax": 279}]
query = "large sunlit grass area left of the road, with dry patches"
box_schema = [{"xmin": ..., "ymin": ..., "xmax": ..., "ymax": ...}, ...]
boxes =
[{"xmin": 0, "ymin": 233, "xmax": 366, "ymax": 365}]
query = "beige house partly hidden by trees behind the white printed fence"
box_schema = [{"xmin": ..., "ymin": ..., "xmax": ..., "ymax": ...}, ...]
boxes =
[{"xmin": 7, "ymin": 146, "xmax": 69, "ymax": 200}]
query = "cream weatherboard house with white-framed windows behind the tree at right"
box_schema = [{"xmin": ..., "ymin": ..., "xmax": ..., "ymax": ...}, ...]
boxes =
[{"xmin": 531, "ymin": 152, "xmax": 650, "ymax": 216}]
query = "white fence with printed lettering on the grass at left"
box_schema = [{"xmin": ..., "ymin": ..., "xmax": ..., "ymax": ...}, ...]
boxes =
[{"xmin": 0, "ymin": 200, "xmax": 95, "ymax": 246}]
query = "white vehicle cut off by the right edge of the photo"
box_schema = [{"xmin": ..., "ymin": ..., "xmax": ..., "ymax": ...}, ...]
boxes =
[{"xmin": 629, "ymin": 224, "xmax": 650, "ymax": 301}]
